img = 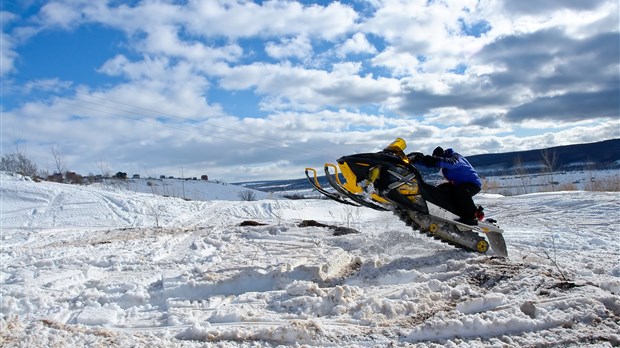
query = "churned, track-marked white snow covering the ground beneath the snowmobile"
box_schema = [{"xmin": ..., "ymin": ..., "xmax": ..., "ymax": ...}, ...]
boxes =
[{"xmin": 0, "ymin": 173, "xmax": 620, "ymax": 347}]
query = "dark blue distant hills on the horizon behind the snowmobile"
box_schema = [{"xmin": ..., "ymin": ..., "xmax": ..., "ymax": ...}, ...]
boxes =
[{"xmin": 236, "ymin": 139, "xmax": 620, "ymax": 192}]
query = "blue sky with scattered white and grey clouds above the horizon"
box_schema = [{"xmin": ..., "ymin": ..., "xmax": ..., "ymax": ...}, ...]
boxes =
[{"xmin": 0, "ymin": 0, "xmax": 620, "ymax": 182}]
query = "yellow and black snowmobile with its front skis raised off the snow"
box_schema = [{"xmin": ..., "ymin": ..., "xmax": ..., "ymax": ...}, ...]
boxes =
[{"xmin": 306, "ymin": 138, "xmax": 508, "ymax": 257}]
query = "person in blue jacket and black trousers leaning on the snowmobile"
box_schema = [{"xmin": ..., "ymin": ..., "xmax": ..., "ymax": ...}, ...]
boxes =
[{"xmin": 412, "ymin": 146, "xmax": 483, "ymax": 225}]
